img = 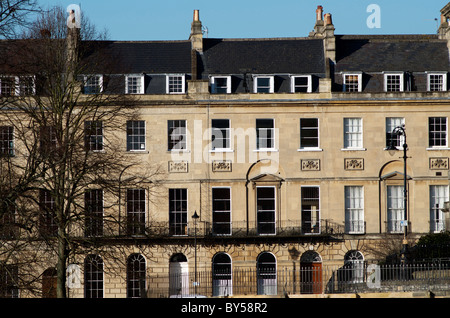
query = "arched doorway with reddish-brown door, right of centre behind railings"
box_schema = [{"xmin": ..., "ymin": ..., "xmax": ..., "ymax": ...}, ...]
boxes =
[{"xmin": 300, "ymin": 251, "xmax": 322, "ymax": 294}]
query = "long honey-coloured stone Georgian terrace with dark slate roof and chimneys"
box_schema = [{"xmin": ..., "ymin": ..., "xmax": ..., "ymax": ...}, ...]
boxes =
[{"xmin": 0, "ymin": 5, "xmax": 450, "ymax": 297}]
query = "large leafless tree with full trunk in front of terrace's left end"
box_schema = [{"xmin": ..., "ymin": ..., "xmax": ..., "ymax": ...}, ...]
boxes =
[{"xmin": 0, "ymin": 8, "xmax": 163, "ymax": 298}]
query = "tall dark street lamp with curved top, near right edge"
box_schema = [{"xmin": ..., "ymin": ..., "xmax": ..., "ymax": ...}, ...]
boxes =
[{"xmin": 386, "ymin": 125, "xmax": 408, "ymax": 262}]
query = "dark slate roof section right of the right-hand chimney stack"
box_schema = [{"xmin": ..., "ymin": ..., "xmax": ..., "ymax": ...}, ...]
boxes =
[{"xmin": 335, "ymin": 35, "xmax": 449, "ymax": 72}]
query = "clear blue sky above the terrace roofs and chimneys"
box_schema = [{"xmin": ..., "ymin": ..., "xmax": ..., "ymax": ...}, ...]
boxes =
[{"xmin": 38, "ymin": 0, "xmax": 450, "ymax": 41}]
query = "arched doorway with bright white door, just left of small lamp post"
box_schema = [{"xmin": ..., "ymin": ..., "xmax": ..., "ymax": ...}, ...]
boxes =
[{"xmin": 169, "ymin": 253, "xmax": 189, "ymax": 297}]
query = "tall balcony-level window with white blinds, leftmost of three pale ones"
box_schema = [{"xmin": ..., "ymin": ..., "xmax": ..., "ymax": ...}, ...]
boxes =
[{"xmin": 344, "ymin": 186, "xmax": 364, "ymax": 234}]
